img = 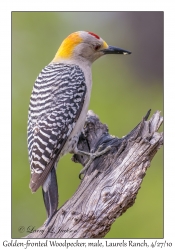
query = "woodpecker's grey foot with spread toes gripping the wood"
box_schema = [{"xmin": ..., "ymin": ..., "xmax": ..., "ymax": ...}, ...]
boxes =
[{"xmin": 75, "ymin": 145, "xmax": 111, "ymax": 179}]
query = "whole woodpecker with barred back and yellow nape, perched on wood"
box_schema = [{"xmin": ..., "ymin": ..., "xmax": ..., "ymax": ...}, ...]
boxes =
[{"xmin": 27, "ymin": 31, "xmax": 131, "ymax": 224}]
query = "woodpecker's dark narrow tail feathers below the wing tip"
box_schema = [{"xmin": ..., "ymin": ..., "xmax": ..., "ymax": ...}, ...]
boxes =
[{"xmin": 42, "ymin": 167, "xmax": 58, "ymax": 226}]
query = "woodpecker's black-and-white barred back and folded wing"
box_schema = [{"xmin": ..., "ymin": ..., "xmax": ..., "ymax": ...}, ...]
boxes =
[{"xmin": 28, "ymin": 64, "xmax": 86, "ymax": 192}]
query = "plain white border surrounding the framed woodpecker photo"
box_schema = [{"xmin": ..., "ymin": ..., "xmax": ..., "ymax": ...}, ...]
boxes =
[{"xmin": 0, "ymin": 0, "xmax": 175, "ymax": 249}]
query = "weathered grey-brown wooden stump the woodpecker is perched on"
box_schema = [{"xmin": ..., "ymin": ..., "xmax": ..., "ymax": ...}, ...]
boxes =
[{"xmin": 26, "ymin": 111, "xmax": 163, "ymax": 238}]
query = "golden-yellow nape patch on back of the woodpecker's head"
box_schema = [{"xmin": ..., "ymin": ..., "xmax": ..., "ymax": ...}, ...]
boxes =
[{"xmin": 53, "ymin": 32, "xmax": 83, "ymax": 61}]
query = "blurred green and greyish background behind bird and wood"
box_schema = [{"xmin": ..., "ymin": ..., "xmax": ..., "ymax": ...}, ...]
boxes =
[{"xmin": 12, "ymin": 12, "xmax": 164, "ymax": 238}]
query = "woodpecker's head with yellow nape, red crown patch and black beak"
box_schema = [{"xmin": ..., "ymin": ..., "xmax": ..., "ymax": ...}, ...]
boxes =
[{"xmin": 52, "ymin": 31, "xmax": 131, "ymax": 63}]
